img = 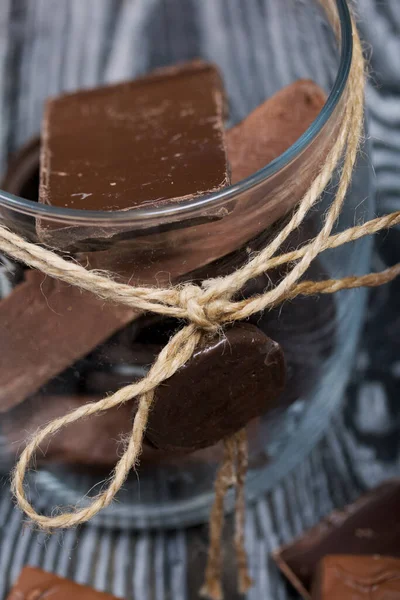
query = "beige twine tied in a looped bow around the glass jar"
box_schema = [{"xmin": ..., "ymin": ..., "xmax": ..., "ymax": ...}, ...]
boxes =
[{"xmin": 0, "ymin": 5, "xmax": 400, "ymax": 599}]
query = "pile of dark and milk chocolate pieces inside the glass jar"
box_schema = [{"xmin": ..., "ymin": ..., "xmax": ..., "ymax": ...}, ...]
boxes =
[{"xmin": 0, "ymin": 61, "xmax": 335, "ymax": 467}]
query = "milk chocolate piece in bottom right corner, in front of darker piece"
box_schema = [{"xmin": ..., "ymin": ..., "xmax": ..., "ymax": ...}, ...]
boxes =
[{"xmin": 312, "ymin": 555, "xmax": 400, "ymax": 600}]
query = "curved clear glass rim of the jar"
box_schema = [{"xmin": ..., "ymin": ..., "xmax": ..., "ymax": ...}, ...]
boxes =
[{"xmin": 0, "ymin": 0, "xmax": 353, "ymax": 226}]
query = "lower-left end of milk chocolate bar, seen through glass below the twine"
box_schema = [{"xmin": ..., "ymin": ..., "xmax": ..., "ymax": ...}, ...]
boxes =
[{"xmin": 0, "ymin": 271, "xmax": 136, "ymax": 412}]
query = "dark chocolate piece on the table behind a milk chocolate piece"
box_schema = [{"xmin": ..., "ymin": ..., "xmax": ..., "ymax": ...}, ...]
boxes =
[{"xmin": 274, "ymin": 479, "xmax": 400, "ymax": 598}]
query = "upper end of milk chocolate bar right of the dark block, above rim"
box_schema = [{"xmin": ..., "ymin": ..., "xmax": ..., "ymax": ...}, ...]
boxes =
[{"xmin": 226, "ymin": 79, "xmax": 326, "ymax": 183}]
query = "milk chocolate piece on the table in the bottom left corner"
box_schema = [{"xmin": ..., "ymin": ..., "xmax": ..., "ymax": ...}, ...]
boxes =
[{"xmin": 7, "ymin": 567, "xmax": 117, "ymax": 600}]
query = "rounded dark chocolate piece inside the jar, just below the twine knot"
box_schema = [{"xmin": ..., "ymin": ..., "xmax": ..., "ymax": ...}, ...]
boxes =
[{"xmin": 146, "ymin": 324, "xmax": 285, "ymax": 452}]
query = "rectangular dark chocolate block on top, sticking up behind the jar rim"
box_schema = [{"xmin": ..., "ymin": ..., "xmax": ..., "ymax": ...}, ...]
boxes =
[{"xmin": 39, "ymin": 61, "xmax": 229, "ymax": 246}]
